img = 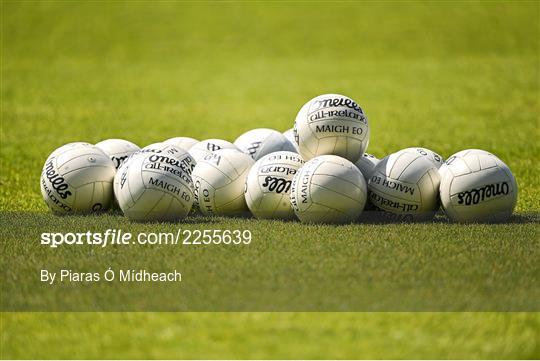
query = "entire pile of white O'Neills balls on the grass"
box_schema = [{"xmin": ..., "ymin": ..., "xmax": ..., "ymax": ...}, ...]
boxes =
[{"xmin": 41, "ymin": 94, "xmax": 517, "ymax": 223}]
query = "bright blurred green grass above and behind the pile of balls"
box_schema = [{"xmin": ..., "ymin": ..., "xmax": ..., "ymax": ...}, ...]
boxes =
[{"xmin": 2, "ymin": 1, "xmax": 540, "ymax": 210}]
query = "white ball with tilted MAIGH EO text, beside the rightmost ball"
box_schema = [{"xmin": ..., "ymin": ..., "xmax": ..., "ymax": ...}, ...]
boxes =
[{"xmin": 368, "ymin": 152, "xmax": 440, "ymax": 221}]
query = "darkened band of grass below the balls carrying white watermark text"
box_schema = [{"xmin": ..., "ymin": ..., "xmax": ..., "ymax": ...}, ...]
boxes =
[{"xmin": 0, "ymin": 212, "xmax": 540, "ymax": 312}]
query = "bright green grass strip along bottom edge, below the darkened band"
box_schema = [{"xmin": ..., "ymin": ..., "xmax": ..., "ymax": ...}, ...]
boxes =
[{"xmin": 3, "ymin": 313, "xmax": 539, "ymax": 359}]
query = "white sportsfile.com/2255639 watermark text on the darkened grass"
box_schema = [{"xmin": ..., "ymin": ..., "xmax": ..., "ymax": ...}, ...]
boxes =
[{"xmin": 40, "ymin": 228, "xmax": 252, "ymax": 248}]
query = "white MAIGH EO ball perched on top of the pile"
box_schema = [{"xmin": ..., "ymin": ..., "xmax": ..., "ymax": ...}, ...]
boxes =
[{"xmin": 294, "ymin": 94, "xmax": 369, "ymax": 163}]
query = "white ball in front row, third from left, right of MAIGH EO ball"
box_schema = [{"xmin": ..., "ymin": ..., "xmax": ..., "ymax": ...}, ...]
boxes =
[{"xmin": 192, "ymin": 149, "xmax": 255, "ymax": 216}]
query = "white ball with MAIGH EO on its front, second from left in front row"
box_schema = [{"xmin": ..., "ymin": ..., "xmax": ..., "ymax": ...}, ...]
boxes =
[{"xmin": 115, "ymin": 152, "xmax": 194, "ymax": 221}]
